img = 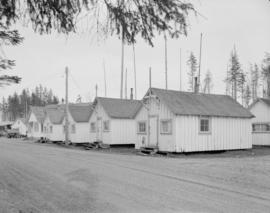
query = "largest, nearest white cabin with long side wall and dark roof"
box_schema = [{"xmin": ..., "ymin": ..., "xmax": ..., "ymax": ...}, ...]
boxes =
[{"xmin": 135, "ymin": 88, "xmax": 253, "ymax": 152}]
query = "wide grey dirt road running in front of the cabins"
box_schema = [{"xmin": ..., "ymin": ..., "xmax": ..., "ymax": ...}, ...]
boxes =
[{"xmin": 0, "ymin": 139, "xmax": 270, "ymax": 213}]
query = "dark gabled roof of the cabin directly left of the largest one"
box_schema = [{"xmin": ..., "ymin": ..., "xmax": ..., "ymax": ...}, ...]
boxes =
[{"xmin": 94, "ymin": 97, "xmax": 142, "ymax": 119}]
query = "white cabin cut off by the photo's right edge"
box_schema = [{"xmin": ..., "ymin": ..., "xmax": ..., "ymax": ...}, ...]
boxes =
[{"xmin": 249, "ymin": 98, "xmax": 270, "ymax": 146}]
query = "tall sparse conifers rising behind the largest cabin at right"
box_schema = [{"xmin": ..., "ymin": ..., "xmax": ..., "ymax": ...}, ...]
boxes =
[{"xmin": 187, "ymin": 48, "xmax": 270, "ymax": 107}]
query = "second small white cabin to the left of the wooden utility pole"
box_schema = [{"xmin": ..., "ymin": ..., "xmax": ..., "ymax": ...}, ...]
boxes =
[{"xmin": 27, "ymin": 106, "xmax": 45, "ymax": 138}]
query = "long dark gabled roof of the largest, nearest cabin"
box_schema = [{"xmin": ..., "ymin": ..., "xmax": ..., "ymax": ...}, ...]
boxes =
[{"xmin": 146, "ymin": 88, "xmax": 253, "ymax": 118}]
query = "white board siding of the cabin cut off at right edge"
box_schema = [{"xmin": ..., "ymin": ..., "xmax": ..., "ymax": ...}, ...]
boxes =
[{"xmin": 250, "ymin": 102, "xmax": 270, "ymax": 145}]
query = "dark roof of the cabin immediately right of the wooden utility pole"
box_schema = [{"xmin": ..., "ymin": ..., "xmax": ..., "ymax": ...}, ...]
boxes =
[{"xmin": 69, "ymin": 103, "xmax": 93, "ymax": 122}]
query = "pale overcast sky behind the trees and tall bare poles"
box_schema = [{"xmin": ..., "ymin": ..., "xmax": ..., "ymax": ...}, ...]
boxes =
[{"xmin": 0, "ymin": 0, "xmax": 270, "ymax": 101}]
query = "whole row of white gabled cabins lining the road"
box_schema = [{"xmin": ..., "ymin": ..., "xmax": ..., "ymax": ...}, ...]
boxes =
[{"xmin": 14, "ymin": 88, "xmax": 270, "ymax": 152}]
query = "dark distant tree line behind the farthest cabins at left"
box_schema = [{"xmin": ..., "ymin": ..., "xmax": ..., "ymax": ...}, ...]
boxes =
[{"xmin": 0, "ymin": 85, "xmax": 59, "ymax": 121}]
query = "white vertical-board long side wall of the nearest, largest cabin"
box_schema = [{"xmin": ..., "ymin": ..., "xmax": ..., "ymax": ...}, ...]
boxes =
[{"xmin": 176, "ymin": 116, "xmax": 252, "ymax": 152}]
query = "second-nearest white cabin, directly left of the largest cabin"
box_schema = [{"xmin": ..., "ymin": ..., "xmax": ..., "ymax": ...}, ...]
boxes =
[{"xmin": 90, "ymin": 97, "xmax": 142, "ymax": 146}]
